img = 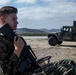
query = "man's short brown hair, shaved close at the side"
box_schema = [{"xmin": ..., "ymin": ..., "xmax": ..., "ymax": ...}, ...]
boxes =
[{"xmin": 0, "ymin": 6, "xmax": 18, "ymax": 17}]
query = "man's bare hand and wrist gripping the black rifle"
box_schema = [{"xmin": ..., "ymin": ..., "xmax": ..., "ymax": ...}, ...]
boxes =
[{"xmin": 14, "ymin": 36, "xmax": 25, "ymax": 57}]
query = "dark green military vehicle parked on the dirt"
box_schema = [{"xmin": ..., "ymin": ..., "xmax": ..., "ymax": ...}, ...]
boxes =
[{"xmin": 48, "ymin": 21, "xmax": 76, "ymax": 46}]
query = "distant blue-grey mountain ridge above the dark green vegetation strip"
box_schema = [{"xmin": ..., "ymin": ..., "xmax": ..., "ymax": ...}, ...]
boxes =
[{"xmin": 16, "ymin": 28, "xmax": 60, "ymax": 33}]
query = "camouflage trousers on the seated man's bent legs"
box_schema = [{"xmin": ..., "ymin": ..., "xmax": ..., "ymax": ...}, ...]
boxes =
[{"xmin": 32, "ymin": 59, "xmax": 76, "ymax": 75}]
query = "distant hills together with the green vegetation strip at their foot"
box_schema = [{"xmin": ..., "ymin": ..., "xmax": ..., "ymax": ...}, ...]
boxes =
[{"xmin": 16, "ymin": 28, "xmax": 59, "ymax": 36}]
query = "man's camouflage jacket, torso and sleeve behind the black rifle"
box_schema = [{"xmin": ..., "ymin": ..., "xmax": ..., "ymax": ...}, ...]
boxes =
[{"xmin": 0, "ymin": 33, "xmax": 19, "ymax": 75}]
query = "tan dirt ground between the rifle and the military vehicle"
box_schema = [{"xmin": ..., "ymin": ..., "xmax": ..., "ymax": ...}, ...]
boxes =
[{"xmin": 25, "ymin": 39, "xmax": 76, "ymax": 62}]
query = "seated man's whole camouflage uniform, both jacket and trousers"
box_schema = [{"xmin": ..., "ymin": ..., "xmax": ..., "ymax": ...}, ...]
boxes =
[{"xmin": 0, "ymin": 34, "xmax": 76, "ymax": 75}]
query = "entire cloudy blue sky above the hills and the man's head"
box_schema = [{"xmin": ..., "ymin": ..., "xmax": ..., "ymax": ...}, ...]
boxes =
[{"xmin": 0, "ymin": 0, "xmax": 76, "ymax": 29}]
